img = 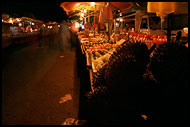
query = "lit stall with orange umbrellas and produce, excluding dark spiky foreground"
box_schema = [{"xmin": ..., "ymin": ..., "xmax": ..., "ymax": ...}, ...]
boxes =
[{"xmin": 60, "ymin": 2, "xmax": 188, "ymax": 91}]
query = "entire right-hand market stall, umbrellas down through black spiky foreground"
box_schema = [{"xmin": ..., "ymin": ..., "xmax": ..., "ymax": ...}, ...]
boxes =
[{"xmin": 60, "ymin": 2, "xmax": 188, "ymax": 124}]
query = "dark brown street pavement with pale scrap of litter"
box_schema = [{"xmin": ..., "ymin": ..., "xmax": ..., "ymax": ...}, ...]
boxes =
[{"xmin": 2, "ymin": 38, "xmax": 79, "ymax": 125}]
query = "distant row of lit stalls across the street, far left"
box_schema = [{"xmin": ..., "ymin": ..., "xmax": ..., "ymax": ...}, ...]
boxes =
[{"xmin": 2, "ymin": 14, "xmax": 60, "ymax": 48}]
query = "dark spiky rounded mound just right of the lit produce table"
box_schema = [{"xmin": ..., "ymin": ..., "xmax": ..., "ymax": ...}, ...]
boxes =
[{"xmin": 105, "ymin": 42, "xmax": 149, "ymax": 89}]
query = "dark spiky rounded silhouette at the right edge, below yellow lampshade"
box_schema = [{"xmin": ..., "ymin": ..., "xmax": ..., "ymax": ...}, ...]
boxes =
[{"xmin": 150, "ymin": 42, "xmax": 188, "ymax": 84}]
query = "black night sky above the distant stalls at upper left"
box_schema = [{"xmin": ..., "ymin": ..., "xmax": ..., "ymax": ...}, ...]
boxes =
[{"xmin": 2, "ymin": 0, "xmax": 67, "ymax": 22}]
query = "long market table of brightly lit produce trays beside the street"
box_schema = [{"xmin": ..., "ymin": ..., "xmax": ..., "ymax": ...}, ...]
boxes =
[{"xmin": 78, "ymin": 32, "xmax": 126, "ymax": 92}]
